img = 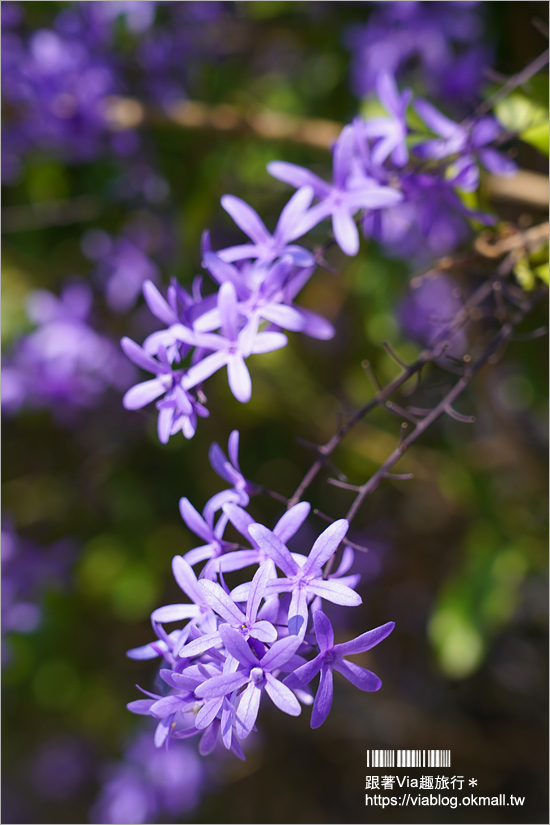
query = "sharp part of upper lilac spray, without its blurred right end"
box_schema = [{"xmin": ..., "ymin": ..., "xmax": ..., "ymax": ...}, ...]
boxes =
[{"xmin": 122, "ymin": 154, "xmax": 401, "ymax": 443}]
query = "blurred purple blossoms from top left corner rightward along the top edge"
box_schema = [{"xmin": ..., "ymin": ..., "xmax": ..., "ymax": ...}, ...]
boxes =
[{"xmin": 2, "ymin": 0, "xmax": 231, "ymax": 183}]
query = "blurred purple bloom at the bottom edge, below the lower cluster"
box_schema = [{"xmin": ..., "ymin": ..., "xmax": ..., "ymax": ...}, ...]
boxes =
[{"xmin": 90, "ymin": 732, "xmax": 206, "ymax": 825}]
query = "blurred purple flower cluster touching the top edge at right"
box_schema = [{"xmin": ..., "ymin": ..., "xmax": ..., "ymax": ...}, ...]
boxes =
[{"xmin": 347, "ymin": 2, "xmax": 492, "ymax": 108}]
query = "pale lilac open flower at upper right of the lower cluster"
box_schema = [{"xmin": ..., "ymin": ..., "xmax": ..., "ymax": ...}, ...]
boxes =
[{"xmin": 249, "ymin": 519, "xmax": 362, "ymax": 639}]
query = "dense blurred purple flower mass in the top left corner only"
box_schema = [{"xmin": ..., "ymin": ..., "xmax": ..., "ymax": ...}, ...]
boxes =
[{"xmin": 2, "ymin": 3, "xmax": 126, "ymax": 182}]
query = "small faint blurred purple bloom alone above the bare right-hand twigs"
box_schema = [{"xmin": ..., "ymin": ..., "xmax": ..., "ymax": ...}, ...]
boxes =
[{"xmin": 397, "ymin": 273, "xmax": 468, "ymax": 359}]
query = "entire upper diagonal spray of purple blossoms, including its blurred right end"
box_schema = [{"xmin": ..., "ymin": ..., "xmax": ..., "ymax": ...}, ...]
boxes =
[{"xmin": 122, "ymin": 73, "xmax": 515, "ymax": 443}]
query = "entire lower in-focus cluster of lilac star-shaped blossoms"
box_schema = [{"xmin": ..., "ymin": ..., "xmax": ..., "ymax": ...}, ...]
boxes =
[{"xmin": 128, "ymin": 431, "xmax": 394, "ymax": 758}]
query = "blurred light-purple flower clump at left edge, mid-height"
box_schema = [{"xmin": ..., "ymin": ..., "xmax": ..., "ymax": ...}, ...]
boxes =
[{"xmin": 2, "ymin": 283, "xmax": 134, "ymax": 420}]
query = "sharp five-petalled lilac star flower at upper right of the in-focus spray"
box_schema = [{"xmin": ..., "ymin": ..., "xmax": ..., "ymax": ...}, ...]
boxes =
[{"xmin": 267, "ymin": 126, "xmax": 402, "ymax": 255}]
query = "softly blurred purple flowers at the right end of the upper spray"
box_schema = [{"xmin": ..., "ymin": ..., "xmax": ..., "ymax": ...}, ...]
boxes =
[{"xmin": 353, "ymin": 72, "xmax": 516, "ymax": 265}]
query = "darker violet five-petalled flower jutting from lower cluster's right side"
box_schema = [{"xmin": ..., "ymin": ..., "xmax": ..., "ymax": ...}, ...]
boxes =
[{"xmin": 284, "ymin": 610, "xmax": 395, "ymax": 728}]
